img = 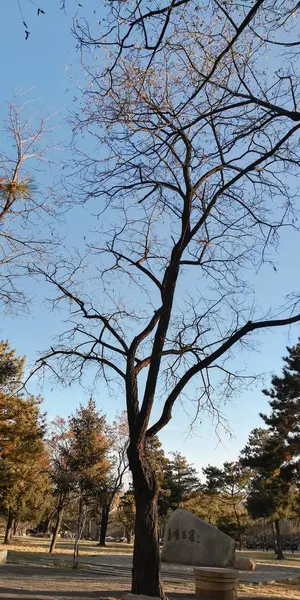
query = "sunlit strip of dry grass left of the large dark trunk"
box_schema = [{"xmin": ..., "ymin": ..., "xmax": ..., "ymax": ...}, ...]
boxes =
[{"xmin": 0, "ymin": 536, "xmax": 133, "ymax": 556}]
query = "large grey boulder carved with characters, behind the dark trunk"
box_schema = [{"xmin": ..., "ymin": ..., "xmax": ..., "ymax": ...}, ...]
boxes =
[{"xmin": 161, "ymin": 509, "xmax": 235, "ymax": 567}]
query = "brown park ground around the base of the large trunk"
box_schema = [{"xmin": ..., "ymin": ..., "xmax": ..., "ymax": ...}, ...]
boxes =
[{"xmin": 0, "ymin": 538, "xmax": 300, "ymax": 600}]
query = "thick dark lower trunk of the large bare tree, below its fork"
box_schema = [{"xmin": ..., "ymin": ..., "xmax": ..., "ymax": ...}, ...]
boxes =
[{"xmin": 128, "ymin": 442, "xmax": 164, "ymax": 598}]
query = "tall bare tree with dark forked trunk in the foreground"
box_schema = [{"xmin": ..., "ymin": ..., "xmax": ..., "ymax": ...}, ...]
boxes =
[{"xmin": 37, "ymin": 0, "xmax": 300, "ymax": 597}]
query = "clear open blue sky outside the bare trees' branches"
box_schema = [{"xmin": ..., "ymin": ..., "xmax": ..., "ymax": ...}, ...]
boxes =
[{"xmin": 0, "ymin": 0, "xmax": 300, "ymax": 478}]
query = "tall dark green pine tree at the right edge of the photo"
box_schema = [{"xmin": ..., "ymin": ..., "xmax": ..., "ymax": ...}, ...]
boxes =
[{"xmin": 239, "ymin": 343, "xmax": 300, "ymax": 558}]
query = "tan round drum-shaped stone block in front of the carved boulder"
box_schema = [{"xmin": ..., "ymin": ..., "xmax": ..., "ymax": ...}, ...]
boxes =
[{"xmin": 194, "ymin": 567, "xmax": 239, "ymax": 600}]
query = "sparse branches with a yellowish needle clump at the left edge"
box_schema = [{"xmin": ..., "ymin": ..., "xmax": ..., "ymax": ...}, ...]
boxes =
[{"xmin": 0, "ymin": 92, "xmax": 55, "ymax": 310}]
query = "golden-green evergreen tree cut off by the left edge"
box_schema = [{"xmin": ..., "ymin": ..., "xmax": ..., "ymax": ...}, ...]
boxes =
[{"xmin": 0, "ymin": 393, "xmax": 48, "ymax": 544}]
